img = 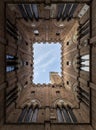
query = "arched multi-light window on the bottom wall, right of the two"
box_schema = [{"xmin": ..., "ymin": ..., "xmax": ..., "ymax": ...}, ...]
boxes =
[{"xmin": 54, "ymin": 99, "xmax": 77, "ymax": 123}]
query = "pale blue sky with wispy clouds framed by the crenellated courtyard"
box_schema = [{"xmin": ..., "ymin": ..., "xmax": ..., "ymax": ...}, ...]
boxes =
[{"xmin": 33, "ymin": 43, "xmax": 61, "ymax": 84}]
